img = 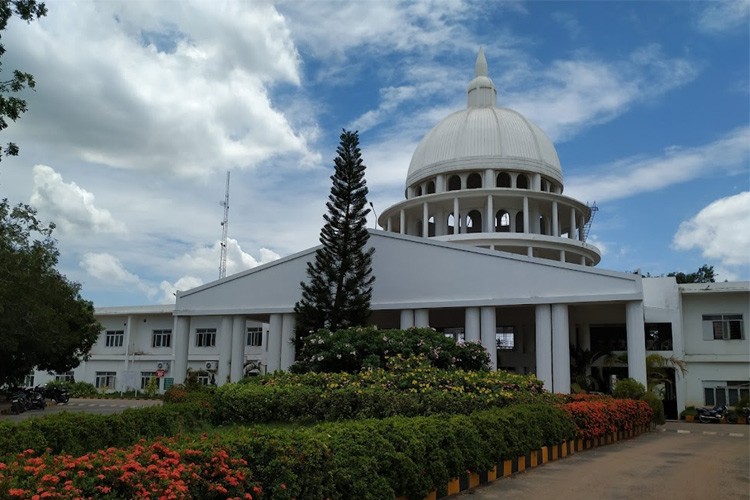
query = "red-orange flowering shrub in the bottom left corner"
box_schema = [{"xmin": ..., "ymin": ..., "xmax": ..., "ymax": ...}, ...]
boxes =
[{"xmin": 0, "ymin": 437, "xmax": 262, "ymax": 499}]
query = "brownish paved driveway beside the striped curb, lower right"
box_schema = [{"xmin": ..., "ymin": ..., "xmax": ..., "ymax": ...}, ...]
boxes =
[{"xmin": 458, "ymin": 422, "xmax": 750, "ymax": 500}]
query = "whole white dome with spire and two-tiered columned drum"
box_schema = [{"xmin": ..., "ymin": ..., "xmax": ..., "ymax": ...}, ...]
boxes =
[{"xmin": 378, "ymin": 49, "xmax": 601, "ymax": 266}]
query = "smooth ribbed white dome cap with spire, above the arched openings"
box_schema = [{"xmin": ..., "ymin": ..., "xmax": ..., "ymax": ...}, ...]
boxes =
[{"xmin": 406, "ymin": 51, "xmax": 563, "ymax": 186}]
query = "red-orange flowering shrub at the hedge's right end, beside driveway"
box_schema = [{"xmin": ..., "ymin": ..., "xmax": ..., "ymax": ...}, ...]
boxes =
[{"xmin": 562, "ymin": 398, "xmax": 652, "ymax": 439}]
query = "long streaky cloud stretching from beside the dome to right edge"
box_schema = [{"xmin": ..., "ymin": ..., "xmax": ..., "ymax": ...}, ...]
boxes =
[{"xmin": 565, "ymin": 127, "xmax": 750, "ymax": 202}]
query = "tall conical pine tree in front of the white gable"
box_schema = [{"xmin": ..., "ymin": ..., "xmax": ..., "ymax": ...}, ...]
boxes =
[{"xmin": 294, "ymin": 130, "xmax": 375, "ymax": 336}]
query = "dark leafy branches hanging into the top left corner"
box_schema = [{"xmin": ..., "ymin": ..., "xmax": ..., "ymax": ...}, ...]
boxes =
[{"xmin": 0, "ymin": 0, "xmax": 47, "ymax": 159}]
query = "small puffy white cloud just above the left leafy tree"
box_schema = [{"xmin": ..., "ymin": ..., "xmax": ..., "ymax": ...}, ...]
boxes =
[{"xmin": 30, "ymin": 165, "xmax": 125, "ymax": 234}]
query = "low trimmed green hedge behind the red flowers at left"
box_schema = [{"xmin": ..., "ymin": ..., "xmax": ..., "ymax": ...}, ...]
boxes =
[{"xmin": 0, "ymin": 403, "xmax": 212, "ymax": 457}]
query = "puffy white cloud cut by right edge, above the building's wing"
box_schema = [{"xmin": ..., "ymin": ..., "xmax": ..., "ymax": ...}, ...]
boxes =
[{"xmin": 673, "ymin": 191, "xmax": 750, "ymax": 274}]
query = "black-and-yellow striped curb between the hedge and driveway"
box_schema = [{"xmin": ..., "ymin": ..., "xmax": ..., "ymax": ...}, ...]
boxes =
[{"xmin": 396, "ymin": 427, "xmax": 649, "ymax": 500}]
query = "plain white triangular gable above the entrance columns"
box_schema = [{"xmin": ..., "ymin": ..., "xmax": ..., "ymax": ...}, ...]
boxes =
[{"xmin": 175, "ymin": 231, "xmax": 642, "ymax": 314}]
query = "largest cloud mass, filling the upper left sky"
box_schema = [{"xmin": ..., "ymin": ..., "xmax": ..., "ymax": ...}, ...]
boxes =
[{"xmin": 4, "ymin": 1, "xmax": 319, "ymax": 177}]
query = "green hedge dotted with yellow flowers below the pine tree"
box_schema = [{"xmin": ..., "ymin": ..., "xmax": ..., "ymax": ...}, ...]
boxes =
[{"xmin": 214, "ymin": 365, "xmax": 551, "ymax": 423}]
